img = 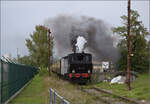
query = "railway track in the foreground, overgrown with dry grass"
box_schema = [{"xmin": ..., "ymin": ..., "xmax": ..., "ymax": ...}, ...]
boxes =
[{"xmin": 78, "ymin": 87, "xmax": 142, "ymax": 104}]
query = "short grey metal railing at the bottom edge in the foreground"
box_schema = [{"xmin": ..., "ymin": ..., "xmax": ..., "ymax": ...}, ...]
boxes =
[{"xmin": 49, "ymin": 88, "xmax": 70, "ymax": 104}]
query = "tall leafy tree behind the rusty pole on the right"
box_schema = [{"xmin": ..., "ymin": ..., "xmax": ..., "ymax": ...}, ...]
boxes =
[{"xmin": 113, "ymin": 10, "xmax": 149, "ymax": 72}]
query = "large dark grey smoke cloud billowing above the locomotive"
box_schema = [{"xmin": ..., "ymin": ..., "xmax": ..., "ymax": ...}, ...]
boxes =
[{"xmin": 45, "ymin": 15, "xmax": 119, "ymax": 61}]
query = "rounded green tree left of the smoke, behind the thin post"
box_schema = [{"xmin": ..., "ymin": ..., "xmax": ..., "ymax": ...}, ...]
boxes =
[{"xmin": 26, "ymin": 25, "xmax": 53, "ymax": 67}]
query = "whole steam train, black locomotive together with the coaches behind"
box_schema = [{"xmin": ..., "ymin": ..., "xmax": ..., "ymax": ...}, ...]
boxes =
[{"xmin": 52, "ymin": 53, "xmax": 93, "ymax": 83}]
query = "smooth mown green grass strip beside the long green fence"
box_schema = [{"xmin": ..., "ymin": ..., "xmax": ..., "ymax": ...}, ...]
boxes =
[{"xmin": 9, "ymin": 75, "xmax": 45, "ymax": 104}]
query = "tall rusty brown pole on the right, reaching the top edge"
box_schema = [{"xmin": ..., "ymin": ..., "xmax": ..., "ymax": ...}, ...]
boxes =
[{"xmin": 126, "ymin": 0, "xmax": 131, "ymax": 90}]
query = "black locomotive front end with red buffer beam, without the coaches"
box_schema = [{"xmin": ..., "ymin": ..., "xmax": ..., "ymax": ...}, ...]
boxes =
[{"xmin": 68, "ymin": 53, "xmax": 92, "ymax": 82}]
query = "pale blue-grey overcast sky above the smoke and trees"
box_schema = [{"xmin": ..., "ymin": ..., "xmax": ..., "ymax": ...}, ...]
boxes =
[{"xmin": 1, "ymin": 0, "xmax": 150, "ymax": 57}]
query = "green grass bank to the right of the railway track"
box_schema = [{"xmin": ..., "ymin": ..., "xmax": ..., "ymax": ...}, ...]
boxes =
[{"xmin": 87, "ymin": 74, "xmax": 150, "ymax": 101}]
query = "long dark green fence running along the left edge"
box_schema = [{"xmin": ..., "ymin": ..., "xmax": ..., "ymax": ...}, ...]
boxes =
[{"xmin": 0, "ymin": 59, "xmax": 38, "ymax": 104}]
